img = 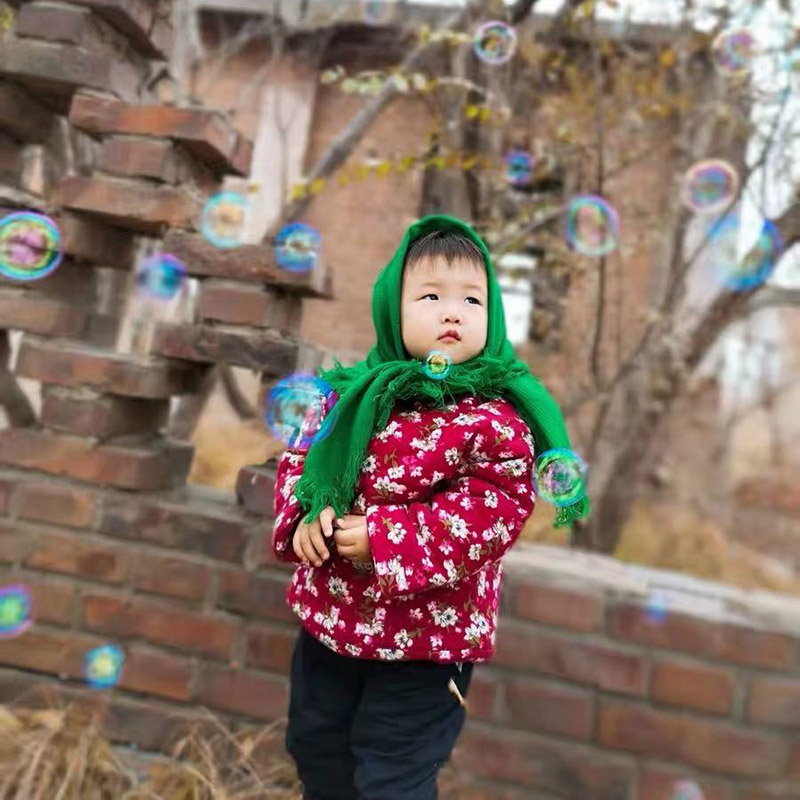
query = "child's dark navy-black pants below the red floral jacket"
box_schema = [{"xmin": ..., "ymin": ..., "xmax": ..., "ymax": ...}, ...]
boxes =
[{"xmin": 286, "ymin": 630, "xmax": 472, "ymax": 800}]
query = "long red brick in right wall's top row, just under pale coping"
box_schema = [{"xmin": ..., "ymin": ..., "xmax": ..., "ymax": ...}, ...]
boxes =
[{"xmin": 609, "ymin": 603, "xmax": 793, "ymax": 669}]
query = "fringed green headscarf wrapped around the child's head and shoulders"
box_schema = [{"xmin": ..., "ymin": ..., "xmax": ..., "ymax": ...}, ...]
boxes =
[{"xmin": 294, "ymin": 214, "xmax": 589, "ymax": 527}]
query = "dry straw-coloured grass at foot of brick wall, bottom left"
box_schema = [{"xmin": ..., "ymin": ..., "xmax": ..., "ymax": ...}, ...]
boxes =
[{"xmin": 0, "ymin": 706, "xmax": 300, "ymax": 800}]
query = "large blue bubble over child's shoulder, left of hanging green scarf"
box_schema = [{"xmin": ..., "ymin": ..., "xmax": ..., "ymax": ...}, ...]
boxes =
[{"xmin": 266, "ymin": 375, "xmax": 336, "ymax": 450}]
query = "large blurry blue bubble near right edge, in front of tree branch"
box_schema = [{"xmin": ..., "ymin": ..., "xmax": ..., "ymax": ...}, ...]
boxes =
[{"xmin": 709, "ymin": 214, "xmax": 783, "ymax": 292}]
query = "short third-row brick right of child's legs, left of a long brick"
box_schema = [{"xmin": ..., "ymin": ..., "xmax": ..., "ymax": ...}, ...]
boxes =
[{"xmin": 505, "ymin": 678, "xmax": 594, "ymax": 740}]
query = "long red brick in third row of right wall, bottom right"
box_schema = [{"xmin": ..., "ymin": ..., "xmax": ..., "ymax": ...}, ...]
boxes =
[{"xmin": 598, "ymin": 701, "xmax": 788, "ymax": 778}]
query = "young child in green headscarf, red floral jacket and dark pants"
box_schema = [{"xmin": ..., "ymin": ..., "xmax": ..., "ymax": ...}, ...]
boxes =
[{"xmin": 272, "ymin": 215, "xmax": 588, "ymax": 800}]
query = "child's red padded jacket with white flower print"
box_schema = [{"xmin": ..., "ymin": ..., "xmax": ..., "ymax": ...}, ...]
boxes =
[{"xmin": 272, "ymin": 396, "xmax": 534, "ymax": 663}]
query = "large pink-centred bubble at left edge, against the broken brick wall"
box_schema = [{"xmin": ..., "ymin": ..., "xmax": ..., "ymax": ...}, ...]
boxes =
[{"xmin": 0, "ymin": 211, "xmax": 62, "ymax": 281}]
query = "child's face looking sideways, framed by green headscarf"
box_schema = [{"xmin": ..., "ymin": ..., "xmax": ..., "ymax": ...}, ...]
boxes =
[{"xmin": 400, "ymin": 256, "xmax": 488, "ymax": 364}]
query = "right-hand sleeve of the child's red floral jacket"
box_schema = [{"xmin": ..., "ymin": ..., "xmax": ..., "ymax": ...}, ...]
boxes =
[{"xmin": 367, "ymin": 412, "xmax": 534, "ymax": 598}]
